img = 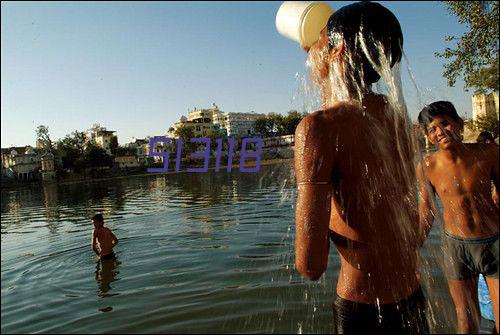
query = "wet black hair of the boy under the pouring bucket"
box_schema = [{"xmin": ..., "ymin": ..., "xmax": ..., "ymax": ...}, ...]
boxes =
[{"xmin": 327, "ymin": 2, "xmax": 403, "ymax": 85}]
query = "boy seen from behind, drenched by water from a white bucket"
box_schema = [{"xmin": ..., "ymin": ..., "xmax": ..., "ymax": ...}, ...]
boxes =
[{"xmin": 295, "ymin": 2, "xmax": 428, "ymax": 334}]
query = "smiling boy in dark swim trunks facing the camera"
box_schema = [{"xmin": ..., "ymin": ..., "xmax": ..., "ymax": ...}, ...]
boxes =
[{"xmin": 418, "ymin": 101, "xmax": 499, "ymax": 333}]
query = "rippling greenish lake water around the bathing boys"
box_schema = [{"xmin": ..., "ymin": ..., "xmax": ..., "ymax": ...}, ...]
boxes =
[{"xmin": 1, "ymin": 163, "xmax": 454, "ymax": 333}]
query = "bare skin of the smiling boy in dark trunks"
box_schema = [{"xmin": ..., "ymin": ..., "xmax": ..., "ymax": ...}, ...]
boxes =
[{"xmin": 419, "ymin": 115, "xmax": 499, "ymax": 333}]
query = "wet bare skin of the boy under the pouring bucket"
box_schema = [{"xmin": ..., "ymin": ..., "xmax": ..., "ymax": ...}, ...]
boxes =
[{"xmin": 294, "ymin": 30, "xmax": 419, "ymax": 304}]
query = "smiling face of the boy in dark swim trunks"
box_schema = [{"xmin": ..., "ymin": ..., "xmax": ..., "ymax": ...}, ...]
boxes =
[{"xmin": 427, "ymin": 115, "xmax": 463, "ymax": 150}]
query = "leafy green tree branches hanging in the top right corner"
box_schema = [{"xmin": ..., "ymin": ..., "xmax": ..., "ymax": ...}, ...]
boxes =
[{"xmin": 435, "ymin": 1, "xmax": 499, "ymax": 93}]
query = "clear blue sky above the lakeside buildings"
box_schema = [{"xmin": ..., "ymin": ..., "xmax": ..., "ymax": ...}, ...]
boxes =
[{"xmin": 1, "ymin": 1, "xmax": 471, "ymax": 147}]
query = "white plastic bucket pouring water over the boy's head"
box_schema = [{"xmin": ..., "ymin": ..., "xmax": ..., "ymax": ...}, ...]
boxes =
[{"xmin": 276, "ymin": 1, "xmax": 333, "ymax": 47}]
